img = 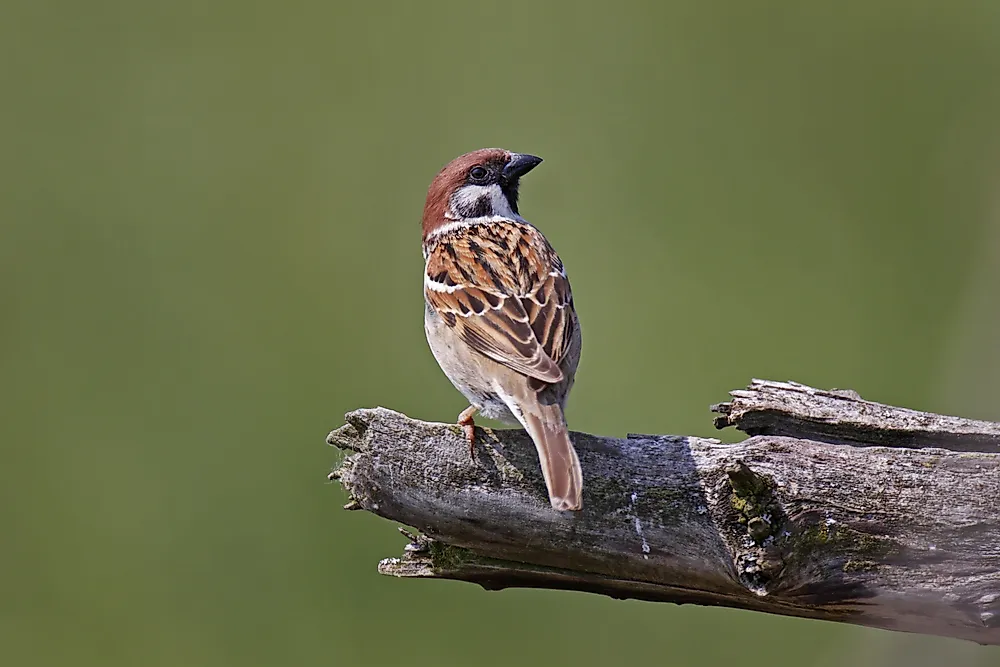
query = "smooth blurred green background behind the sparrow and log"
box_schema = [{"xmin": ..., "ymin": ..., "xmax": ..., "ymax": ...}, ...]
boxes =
[{"xmin": 0, "ymin": 0, "xmax": 1000, "ymax": 667}]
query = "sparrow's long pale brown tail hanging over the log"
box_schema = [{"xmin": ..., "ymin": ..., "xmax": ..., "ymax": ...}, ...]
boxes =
[{"xmin": 521, "ymin": 403, "xmax": 583, "ymax": 510}]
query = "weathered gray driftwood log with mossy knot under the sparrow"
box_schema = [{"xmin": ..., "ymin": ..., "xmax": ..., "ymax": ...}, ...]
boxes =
[{"xmin": 328, "ymin": 381, "xmax": 1000, "ymax": 645}]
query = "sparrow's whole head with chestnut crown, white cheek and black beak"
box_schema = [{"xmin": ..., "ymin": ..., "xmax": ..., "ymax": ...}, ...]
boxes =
[{"xmin": 423, "ymin": 148, "xmax": 542, "ymax": 240}]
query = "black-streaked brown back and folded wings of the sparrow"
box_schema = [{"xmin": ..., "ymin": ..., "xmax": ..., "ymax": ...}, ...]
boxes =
[{"xmin": 424, "ymin": 221, "xmax": 575, "ymax": 383}]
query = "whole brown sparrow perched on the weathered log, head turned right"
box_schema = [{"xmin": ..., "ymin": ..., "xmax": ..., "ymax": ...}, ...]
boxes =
[{"xmin": 423, "ymin": 148, "xmax": 583, "ymax": 510}]
